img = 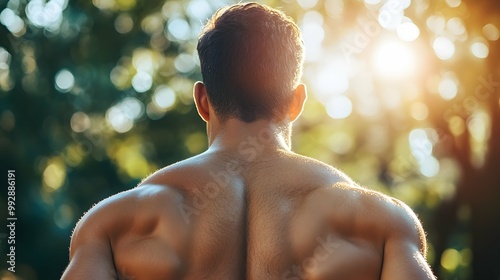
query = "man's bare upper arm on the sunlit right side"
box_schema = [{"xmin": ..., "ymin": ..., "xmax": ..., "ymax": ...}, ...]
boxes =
[{"xmin": 381, "ymin": 201, "xmax": 435, "ymax": 280}]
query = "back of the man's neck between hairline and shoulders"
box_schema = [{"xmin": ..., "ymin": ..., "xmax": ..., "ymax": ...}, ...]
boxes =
[{"xmin": 208, "ymin": 119, "xmax": 291, "ymax": 152}]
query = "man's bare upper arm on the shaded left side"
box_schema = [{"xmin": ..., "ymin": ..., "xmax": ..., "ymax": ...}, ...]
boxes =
[{"xmin": 61, "ymin": 201, "xmax": 117, "ymax": 280}]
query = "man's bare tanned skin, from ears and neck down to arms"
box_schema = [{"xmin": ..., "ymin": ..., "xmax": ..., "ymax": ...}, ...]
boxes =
[{"xmin": 62, "ymin": 83, "xmax": 435, "ymax": 280}]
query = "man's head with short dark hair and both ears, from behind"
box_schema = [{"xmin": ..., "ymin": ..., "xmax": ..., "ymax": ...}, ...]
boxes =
[{"xmin": 195, "ymin": 3, "xmax": 306, "ymax": 123}]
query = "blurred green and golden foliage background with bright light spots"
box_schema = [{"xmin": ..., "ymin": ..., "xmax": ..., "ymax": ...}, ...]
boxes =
[{"xmin": 0, "ymin": 0, "xmax": 500, "ymax": 280}]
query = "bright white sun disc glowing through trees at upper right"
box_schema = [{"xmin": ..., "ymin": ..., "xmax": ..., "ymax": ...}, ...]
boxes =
[{"xmin": 372, "ymin": 38, "xmax": 417, "ymax": 79}]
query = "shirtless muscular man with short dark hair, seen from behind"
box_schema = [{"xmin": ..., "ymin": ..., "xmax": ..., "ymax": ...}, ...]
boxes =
[{"xmin": 62, "ymin": 3, "xmax": 434, "ymax": 280}]
